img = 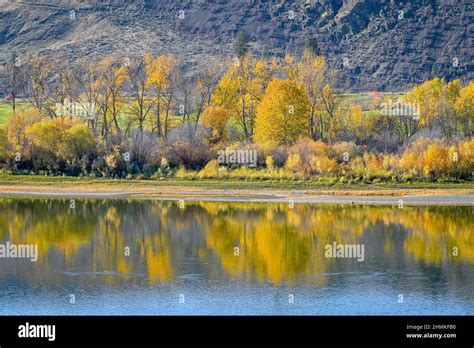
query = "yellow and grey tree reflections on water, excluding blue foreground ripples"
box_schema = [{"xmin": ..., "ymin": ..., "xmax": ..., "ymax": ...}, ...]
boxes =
[{"xmin": 0, "ymin": 198, "xmax": 474, "ymax": 314}]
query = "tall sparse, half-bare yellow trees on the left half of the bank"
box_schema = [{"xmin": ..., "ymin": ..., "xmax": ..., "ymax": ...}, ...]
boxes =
[{"xmin": 3, "ymin": 54, "xmax": 221, "ymax": 141}]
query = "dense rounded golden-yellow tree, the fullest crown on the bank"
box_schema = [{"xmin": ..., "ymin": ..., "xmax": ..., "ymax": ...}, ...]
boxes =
[{"xmin": 255, "ymin": 79, "xmax": 309, "ymax": 145}]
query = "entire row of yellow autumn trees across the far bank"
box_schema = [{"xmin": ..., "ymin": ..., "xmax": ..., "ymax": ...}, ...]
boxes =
[{"xmin": 0, "ymin": 40, "xmax": 474, "ymax": 176}]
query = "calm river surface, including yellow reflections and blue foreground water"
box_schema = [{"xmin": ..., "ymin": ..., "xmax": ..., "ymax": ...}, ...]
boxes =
[{"xmin": 0, "ymin": 198, "xmax": 474, "ymax": 315}]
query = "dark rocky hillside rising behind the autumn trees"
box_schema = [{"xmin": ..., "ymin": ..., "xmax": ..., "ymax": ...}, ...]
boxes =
[{"xmin": 0, "ymin": 0, "xmax": 474, "ymax": 91}]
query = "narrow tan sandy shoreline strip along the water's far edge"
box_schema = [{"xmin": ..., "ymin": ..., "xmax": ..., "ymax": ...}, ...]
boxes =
[{"xmin": 0, "ymin": 185, "xmax": 474, "ymax": 206}]
